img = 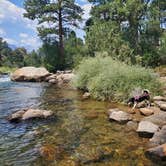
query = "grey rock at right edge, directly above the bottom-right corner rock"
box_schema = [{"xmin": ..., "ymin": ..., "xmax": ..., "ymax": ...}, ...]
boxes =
[{"xmin": 149, "ymin": 125, "xmax": 166, "ymax": 146}]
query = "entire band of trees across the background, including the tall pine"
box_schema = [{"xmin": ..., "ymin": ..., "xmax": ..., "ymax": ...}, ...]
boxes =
[{"xmin": 0, "ymin": 0, "xmax": 166, "ymax": 72}]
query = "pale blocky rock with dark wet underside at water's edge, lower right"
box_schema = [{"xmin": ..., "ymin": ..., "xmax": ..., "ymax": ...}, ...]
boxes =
[{"xmin": 137, "ymin": 121, "xmax": 159, "ymax": 138}]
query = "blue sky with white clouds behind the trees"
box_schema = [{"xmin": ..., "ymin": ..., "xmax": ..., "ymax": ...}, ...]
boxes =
[{"xmin": 0, "ymin": 0, "xmax": 92, "ymax": 50}]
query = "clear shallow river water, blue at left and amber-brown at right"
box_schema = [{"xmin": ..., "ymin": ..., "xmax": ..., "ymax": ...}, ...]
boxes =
[{"xmin": 0, "ymin": 76, "xmax": 159, "ymax": 166}]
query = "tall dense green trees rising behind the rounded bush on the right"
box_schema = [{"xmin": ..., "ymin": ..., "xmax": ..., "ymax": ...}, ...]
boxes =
[{"xmin": 85, "ymin": 0, "xmax": 166, "ymax": 67}]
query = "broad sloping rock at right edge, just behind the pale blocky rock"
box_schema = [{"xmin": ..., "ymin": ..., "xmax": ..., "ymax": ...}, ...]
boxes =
[{"xmin": 142, "ymin": 111, "xmax": 166, "ymax": 127}]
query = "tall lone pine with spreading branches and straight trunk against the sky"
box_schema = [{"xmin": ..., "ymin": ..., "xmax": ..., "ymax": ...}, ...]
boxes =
[{"xmin": 24, "ymin": 0, "xmax": 83, "ymax": 68}]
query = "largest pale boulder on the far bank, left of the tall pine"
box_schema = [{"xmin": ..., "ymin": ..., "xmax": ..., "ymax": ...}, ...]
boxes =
[{"xmin": 11, "ymin": 67, "xmax": 50, "ymax": 82}]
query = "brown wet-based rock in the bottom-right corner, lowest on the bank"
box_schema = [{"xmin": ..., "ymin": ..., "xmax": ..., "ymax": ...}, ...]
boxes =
[{"xmin": 145, "ymin": 144, "xmax": 166, "ymax": 161}]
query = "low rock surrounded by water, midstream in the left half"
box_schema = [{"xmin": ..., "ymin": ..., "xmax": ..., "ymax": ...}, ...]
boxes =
[{"xmin": 8, "ymin": 109, "xmax": 53, "ymax": 122}]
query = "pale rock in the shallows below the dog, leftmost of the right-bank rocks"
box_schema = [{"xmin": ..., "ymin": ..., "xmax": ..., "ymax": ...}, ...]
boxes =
[{"xmin": 109, "ymin": 109, "xmax": 132, "ymax": 123}]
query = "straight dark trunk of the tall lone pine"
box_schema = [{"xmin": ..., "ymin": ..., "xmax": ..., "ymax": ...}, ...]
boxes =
[{"xmin": 59, "ymin": 2, "xmax": 65, "ymax": 69}]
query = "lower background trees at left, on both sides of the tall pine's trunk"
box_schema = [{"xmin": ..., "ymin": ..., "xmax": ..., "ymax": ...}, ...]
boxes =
[{"xmin": 0, "ymin": 31, "xmax": 84, "ymax": 72}]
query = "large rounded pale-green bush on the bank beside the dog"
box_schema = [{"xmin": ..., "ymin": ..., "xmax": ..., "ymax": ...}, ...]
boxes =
[{"xmin": 74, "ymin": 57, "xmax": 161, "ymax": 101}]
